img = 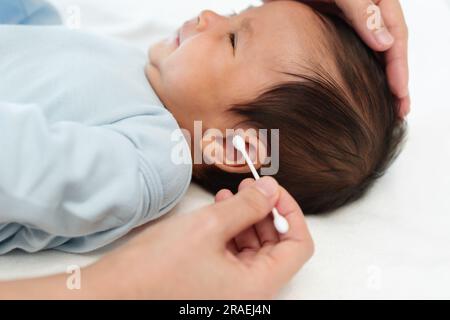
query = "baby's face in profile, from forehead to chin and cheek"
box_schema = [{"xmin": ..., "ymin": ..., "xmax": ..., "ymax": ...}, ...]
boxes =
[{"xmin": 146, "ymin": 1, "xmax": 320, "ymax": 133}]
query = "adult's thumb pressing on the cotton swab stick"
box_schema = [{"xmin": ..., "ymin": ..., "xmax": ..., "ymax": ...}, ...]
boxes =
[{"xmin": 204, "ymin": 177, "xmax": 280, "ymax": 241}]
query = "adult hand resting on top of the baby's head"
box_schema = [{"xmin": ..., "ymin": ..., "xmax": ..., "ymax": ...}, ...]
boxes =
[{"xmin": 264, "ymin": 0, "xmax": 411, "ymax": 118}]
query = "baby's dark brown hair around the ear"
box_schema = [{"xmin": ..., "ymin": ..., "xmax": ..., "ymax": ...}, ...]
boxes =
[{"xmin": 194, "ymin": 14, "xmax": 406, "ymax": 214}]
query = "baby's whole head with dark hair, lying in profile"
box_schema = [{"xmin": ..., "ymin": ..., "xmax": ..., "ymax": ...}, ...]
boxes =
[{"xmin": 147, "ymin": 1, "xmax": 405, "ymax": 213}]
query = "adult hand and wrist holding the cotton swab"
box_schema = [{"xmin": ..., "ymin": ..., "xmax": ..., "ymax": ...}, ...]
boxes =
[{"xmin": 0, "ymin": 177, "xmax": 313, "ymax": 299}]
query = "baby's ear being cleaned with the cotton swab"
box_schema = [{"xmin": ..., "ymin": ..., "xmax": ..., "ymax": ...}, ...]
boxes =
[{"xmin": 202, "ymin": 129, "xmax": 268, "ymax": 173}]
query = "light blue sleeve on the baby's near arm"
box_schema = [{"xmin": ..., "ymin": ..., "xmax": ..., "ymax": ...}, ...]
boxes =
[{"xmin": 0, "ymin": 103, "xmax": 171, "ymax": 254}]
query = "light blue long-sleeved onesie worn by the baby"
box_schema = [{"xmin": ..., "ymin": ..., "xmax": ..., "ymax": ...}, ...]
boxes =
[{"xmin": 0, "ymin": 0, "xmax": 192, "ymax": 254}]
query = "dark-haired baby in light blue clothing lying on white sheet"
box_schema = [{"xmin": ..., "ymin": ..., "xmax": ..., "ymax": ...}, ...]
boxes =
[{"xmin": 0, "ymin": 0, "xmax": 405, "ymax": 254}]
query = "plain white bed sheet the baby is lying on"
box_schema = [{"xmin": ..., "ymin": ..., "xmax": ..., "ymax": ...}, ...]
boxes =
[{"xmin": 0, "ymin": 0, "xmax": 450, "ymax": 299}]
